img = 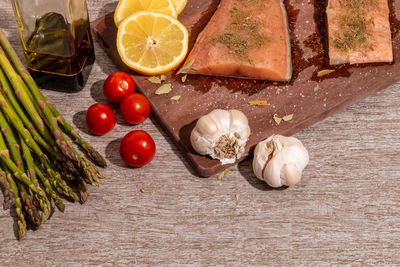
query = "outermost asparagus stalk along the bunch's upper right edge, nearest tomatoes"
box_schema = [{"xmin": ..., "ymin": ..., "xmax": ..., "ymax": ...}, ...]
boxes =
[{"xmin": 0, "ymin": 29, "xmax": 107, "ymax": 167}]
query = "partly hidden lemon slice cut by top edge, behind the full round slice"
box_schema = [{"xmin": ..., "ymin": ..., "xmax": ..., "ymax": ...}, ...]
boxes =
[{"xmin": 114, "ymin": 0, "xmax": 178, "ymax": 27}]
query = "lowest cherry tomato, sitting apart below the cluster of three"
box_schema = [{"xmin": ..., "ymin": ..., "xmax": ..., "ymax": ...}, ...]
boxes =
[{"xmin": 119, "ymin": 130, "xmax": 156, "ymax": 167}]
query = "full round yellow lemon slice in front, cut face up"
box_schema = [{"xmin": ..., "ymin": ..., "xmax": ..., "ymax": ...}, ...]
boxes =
[{"xmin": 117, "ymin": 11, "xmax": 189, "ymax": 75}]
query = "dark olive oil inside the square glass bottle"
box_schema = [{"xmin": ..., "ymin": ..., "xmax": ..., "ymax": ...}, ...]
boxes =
[{"xmin": 24, "ymin": 12, "xmax": 94, "ymax": 92}]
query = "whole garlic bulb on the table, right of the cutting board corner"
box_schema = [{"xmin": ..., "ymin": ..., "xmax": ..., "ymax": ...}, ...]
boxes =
[{"xmin": 253, "ymin": 135, "xmax": 309, "ymax": 187}]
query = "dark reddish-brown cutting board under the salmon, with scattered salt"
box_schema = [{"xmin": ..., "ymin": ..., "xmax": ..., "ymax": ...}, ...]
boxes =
[{"xmin": 92, "ymin": 0, "xmax": 400, "ymax": 176}]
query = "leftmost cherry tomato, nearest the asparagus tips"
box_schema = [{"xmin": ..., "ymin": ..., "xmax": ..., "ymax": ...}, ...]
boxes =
[{"xmin": 86, "ymin": 103, "xmax": 116, "ymax": 135}]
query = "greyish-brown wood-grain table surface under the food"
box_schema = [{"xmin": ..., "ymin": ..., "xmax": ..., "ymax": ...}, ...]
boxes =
[{"xmin": 0, "ymin": 0, "xmax": 400, "ymax": 266}]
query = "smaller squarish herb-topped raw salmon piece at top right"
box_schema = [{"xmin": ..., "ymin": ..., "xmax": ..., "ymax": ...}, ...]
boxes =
[{"xmin": 326, "ymin": 0, "xmax": 393, "ymax": 65}]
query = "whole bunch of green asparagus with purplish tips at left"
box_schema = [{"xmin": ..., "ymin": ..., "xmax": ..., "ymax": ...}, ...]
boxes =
[{"xmin": 0, "ymin": 29, "xmax": 106, "ymax": 239}]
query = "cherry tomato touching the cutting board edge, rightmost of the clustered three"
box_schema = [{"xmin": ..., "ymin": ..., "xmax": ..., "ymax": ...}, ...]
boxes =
[{"xmin": 119, "ymin": 93, "xmax": 151, "ymax": 124}]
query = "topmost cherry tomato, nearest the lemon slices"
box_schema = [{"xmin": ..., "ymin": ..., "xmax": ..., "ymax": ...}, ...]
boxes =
[{"xmin": 103, "ymin": 71, "xmax": 135, "ymax": 104}]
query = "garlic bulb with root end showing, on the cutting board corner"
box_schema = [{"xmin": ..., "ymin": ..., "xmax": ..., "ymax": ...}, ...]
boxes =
[{"xmin": 190, "ymin": 109, "xmax": 250, "ymax": 164}]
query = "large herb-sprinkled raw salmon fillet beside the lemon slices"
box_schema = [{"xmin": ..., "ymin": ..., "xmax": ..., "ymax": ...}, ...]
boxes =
[{"xmin": 182, "ymin": 0, "xmax": 292, "ymax": 81}]
